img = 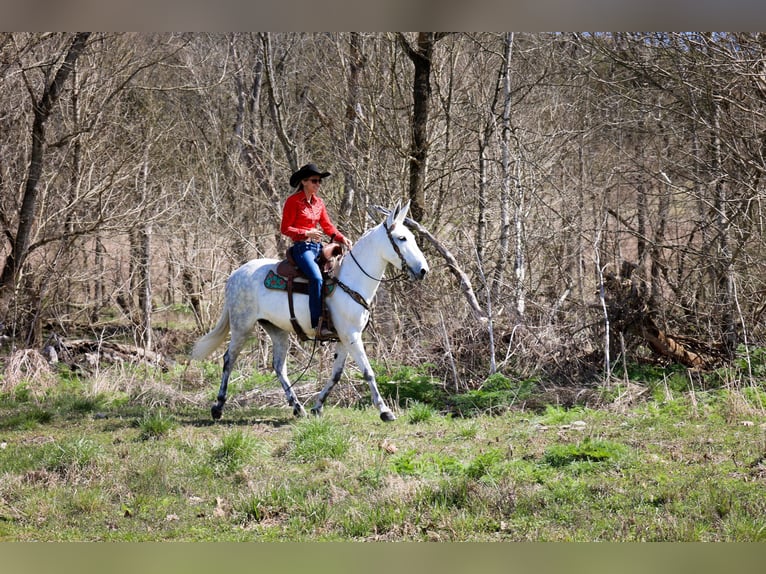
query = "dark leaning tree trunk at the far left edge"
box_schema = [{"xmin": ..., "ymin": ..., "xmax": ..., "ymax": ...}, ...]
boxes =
[{"xmin": 0, "ymin": 32, "xmax": 90, "ymax": 290}]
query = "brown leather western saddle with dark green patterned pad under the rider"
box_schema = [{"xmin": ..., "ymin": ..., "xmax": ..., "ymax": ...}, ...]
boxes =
[{"xmin": 264, "ymin": 243, "xmax": 343, "ymax": 341}]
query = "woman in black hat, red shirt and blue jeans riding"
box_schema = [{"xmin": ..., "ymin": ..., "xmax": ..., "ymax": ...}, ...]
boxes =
[{"xmin": 281, "ymin": 163, "xmax": 351, "ymax": 340}]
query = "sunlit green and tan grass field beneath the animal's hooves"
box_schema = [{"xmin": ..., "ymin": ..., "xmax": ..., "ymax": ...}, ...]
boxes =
[{"xmin": 0, "ymin": 363, "xmax": 766, "ymax": 541}]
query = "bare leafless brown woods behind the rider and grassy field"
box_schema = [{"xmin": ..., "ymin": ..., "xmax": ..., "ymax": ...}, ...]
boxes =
[{"xmin": 0, "ymin": 32, "xmax": 766, "ymax": 388}]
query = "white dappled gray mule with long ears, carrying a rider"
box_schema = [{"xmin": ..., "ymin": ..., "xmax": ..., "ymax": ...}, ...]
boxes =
[{"xmin": 192, "ymin": 202, "xmax": 428, "ymax": 421}]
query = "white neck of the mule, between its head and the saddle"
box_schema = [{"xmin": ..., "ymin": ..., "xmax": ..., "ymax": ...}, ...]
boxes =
[{"xmin": 338, "ymin": 226, "xmax": 388, "ymax": 301}]
